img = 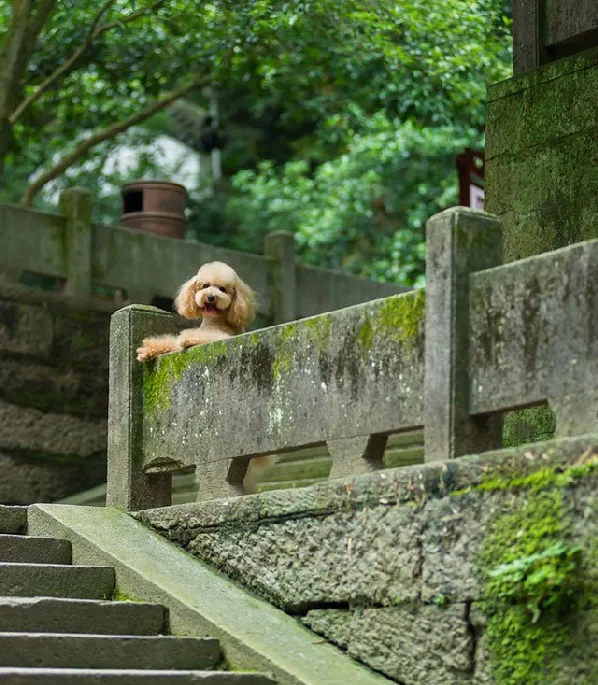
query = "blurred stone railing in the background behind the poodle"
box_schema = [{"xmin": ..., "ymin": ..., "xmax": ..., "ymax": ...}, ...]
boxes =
[{"xmin": 0, "ymin": 188, "xmax": 409, "ymax": 323}]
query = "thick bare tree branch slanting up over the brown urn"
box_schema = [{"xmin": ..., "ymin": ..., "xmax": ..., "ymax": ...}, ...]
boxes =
[{"xmin": 20, "ymin": 74, "xmax": 209, "ymax": 207}]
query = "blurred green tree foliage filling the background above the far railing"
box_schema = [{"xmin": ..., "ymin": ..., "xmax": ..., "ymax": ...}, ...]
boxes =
[{"xmin": 0, "ymin": 0, "xmax": 510, "ymax": 284}]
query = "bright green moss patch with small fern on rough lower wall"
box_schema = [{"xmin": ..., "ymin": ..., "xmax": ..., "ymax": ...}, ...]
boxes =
[{"xmin": 480, "ymin": 487, "xmax": 580, "ymax": 685}]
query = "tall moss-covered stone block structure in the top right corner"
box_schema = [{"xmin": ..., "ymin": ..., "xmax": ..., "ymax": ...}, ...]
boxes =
[{"xmin": 485, "ymin": 0, "xmax": 598, "ymax": 262}]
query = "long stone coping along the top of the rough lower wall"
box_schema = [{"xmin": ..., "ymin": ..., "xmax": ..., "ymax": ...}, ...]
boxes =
[{"xmin": 133, "ymin": 434, "xmax": 598, "ymax": 530}]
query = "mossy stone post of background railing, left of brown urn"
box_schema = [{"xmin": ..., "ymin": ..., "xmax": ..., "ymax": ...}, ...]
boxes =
[{"xmin": 58, "ymin": 188, "xmax": 92, "ymax": 298}]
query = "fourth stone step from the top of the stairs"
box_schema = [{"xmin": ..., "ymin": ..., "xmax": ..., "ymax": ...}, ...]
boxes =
[{"xmin": 0, "ymin": 596, "xmax": 167, "ymax": 635}]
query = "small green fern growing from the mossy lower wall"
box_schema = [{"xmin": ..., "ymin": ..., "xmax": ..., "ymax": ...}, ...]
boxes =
[{"xmin": 488, "ymin": 541, "xmax": 581, "ymax": 623}]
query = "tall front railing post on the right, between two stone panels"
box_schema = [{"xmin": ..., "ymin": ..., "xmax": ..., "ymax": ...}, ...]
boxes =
[{"xmin": 424, "ymin": 207, "xmax": 501, "ymax": 462}]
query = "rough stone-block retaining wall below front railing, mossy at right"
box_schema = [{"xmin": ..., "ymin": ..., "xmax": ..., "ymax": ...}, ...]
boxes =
[{"xmin": 136, "ymin": 436, "xmax": 598, "ymax": 685}]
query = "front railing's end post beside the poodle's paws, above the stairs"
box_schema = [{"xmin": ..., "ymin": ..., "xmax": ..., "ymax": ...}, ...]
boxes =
[{"xmin": 106, "ymin": 305, "xmax": 175, "ymax": 511}]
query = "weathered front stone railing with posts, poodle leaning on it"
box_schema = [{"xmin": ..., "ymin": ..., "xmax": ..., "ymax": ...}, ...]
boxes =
[{"xmin": 107, "ymin": 208, "xmax": 598, "ymax": 509}]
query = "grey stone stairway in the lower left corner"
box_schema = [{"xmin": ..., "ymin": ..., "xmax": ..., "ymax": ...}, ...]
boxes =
[{"xmin": 0, "ymin": 506, "xmax": 274, "ymax": 685}]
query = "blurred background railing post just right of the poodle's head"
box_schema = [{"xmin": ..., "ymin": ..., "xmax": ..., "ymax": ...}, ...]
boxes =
[{"xmin": 264, "ymin": 231, "xmax": 297, "ymax": 324}]
